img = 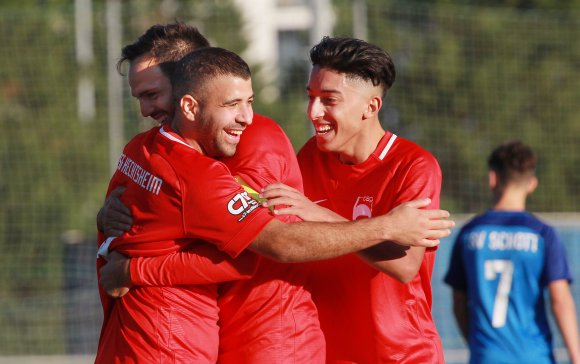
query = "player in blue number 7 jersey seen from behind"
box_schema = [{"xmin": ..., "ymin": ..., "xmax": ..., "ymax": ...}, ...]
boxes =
[{"xmin": 445, "ymin": 141, "xmax": 580, "ymax": 364}]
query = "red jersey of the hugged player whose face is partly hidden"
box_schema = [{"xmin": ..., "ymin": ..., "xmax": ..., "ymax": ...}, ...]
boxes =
[{"xmin": 125, "ymin": 114, "xmax": 325, "ymax": 364}]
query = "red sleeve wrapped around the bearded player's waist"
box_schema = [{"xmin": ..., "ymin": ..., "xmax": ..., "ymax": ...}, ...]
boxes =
[{"xmin": 130, "ymin": 243, "xmax": 259, "ymax": 286}]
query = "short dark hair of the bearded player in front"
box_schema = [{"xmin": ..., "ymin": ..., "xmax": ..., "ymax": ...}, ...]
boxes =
[{"xmin": 171, "ymin": 47, "xmax": 252, "ymax": 102}]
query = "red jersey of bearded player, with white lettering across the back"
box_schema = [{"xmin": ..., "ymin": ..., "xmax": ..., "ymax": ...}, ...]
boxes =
[{"xmin": 95, "ymin": 126, "xmax": 273, "ymax": 363}]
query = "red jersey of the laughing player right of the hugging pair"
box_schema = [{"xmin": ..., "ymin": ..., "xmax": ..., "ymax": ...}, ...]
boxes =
[{"xmin": 298, "ymin": 132, "xmax": 444, "ymax": 364}]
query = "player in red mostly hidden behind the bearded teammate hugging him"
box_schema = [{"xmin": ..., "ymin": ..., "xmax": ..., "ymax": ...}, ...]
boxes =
[{"xmin": 98, "ymin": 23, "xmax": 324, "ymax": 362}]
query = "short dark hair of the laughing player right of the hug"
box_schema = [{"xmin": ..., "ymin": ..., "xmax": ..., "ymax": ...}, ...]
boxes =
[{"xmin": 310, "ymin": 36, "xmax": 395, "ymax": 96}]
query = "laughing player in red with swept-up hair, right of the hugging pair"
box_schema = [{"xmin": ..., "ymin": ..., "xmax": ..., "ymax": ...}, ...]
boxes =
[{"xmin": 263, "ymin": 37, "xmax": 444, "ymax": 364}]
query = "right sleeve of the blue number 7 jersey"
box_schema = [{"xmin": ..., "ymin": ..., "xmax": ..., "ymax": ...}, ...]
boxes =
[{"xmin": 543, "ymin": 226, "xmax": 572, "ymax": 284}]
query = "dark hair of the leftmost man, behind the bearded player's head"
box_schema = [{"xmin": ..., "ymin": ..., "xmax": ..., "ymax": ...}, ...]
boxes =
[{"xmin": 117, "ymin": 22, "xmax": 210, "ymax": 77}]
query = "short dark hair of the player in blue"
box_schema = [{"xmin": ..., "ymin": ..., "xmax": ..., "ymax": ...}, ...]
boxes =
[{"xmin": 487, "ymin": 140, "xmax": 537, "ymax": 187}]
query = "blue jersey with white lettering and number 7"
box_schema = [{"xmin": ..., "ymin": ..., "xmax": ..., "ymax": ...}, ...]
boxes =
[{"xmin": 445, "ymin": 210, "xmax": 572, "ymax": 364}]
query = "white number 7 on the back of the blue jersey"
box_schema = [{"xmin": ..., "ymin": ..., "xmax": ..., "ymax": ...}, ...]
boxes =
[{"xmin": 484, "ymin": 260, "xmax": 514, "ymax": 327}]
